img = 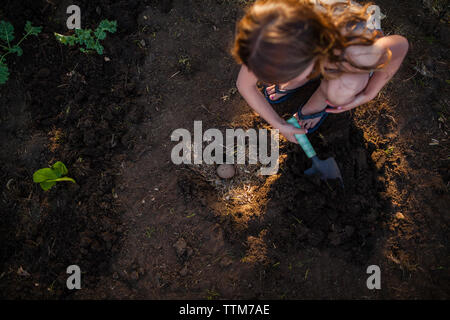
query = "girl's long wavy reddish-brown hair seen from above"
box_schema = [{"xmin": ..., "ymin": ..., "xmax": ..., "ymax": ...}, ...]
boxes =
[{"xmin": 231, "ymin": 0, "xmax": 391, "ymax": 84}]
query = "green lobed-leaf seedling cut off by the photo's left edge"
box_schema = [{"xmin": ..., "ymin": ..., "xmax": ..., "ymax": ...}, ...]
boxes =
[{"xmin": 0, "ymin": 20, "xmax": 42, "ymax": 84}]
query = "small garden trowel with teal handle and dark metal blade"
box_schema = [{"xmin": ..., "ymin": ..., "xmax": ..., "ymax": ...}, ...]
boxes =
[{"xmin": 287, "ymin": 117, "xmax": 344, "ymax": 187}]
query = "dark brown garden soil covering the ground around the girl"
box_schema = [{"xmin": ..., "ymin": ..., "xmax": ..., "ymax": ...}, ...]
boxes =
[{"xmin": 0, "ymin": 0, "xmax": 450, "ymax": 299}]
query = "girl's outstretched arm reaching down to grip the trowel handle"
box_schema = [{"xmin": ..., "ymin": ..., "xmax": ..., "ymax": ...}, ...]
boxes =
[{"xmin": 236, "ymin": 65, "xmax": 306, "ymax": 143}]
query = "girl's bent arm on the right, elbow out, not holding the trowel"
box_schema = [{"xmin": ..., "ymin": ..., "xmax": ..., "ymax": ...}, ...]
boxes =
[{"xmin": 326, "ymin": 35, "xmax": 409, "ymax": 113}]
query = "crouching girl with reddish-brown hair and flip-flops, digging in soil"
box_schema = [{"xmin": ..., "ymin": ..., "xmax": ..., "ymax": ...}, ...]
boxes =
[{"xmin": 233, "ymin": 0, "xmax": 408, "ymax": 143}]
